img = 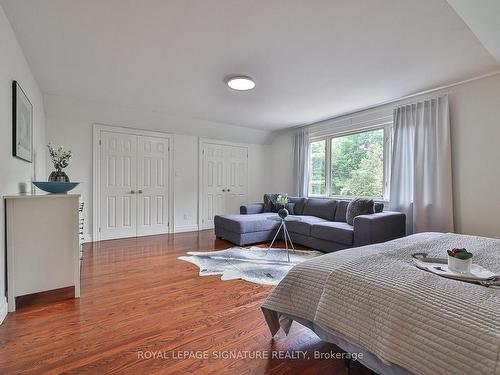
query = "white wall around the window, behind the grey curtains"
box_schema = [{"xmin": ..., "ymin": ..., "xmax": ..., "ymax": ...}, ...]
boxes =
[{"xmin": 272, "ymin": 74, "xmax": 500, "ymax": 237}]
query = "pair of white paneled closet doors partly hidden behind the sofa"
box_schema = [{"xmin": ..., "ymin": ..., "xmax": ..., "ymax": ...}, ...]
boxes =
[{"xmin": 201, "ymin": 143, "xmax": 248, "ymax": 229}]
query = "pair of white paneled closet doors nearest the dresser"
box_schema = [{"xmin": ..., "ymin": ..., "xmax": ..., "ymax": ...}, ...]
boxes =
[{"xmin": 96, "ymin": 130, "xmax": 171, "ymax": 240}]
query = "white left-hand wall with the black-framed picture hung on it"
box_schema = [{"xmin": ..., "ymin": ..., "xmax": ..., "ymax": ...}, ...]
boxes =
[{"xmin": 0, "ymin": 6, "xmax": 45, "ymax": 322}]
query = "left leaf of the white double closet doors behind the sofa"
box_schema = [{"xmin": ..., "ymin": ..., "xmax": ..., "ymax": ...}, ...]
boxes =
[{"xmin": 201, "ymin": 143, "xmax": 226, "ymax": 228}]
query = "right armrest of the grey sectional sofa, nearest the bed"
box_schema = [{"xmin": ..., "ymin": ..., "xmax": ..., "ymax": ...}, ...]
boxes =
[{"xmin": 353, "ymin": 211, "xmax": 406, "ymax": 246}]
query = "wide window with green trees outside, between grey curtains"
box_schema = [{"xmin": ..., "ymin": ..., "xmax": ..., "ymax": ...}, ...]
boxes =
[{"xmin": 309, "ymin": 127, "xmax": 390, "ymax": 199}]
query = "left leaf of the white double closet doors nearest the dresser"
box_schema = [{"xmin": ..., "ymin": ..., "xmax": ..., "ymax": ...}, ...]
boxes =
[{"xmin": 99, "ymin": 131, "xmax": 137, "ymax": 240}]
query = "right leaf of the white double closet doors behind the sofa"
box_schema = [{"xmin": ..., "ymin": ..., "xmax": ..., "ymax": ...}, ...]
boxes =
[{"xmin": 225, "ymin": 146, "xmax": 248, "ymax": 214}]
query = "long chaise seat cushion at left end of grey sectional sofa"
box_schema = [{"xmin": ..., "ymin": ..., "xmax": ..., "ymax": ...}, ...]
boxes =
[{"xmin": 214, "ymin": 212, "xmax": 280, "ymax": 233}]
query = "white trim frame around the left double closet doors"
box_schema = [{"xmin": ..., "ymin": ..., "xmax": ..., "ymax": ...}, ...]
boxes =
[{"xmin": 92, "ymin": 124, "xmax": 174, "ymax": 241}]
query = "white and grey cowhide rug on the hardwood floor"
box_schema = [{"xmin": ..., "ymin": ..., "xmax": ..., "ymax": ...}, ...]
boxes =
[{"xmin": 178, "ymin": 246, "xmax": 323, "ymax": 285}]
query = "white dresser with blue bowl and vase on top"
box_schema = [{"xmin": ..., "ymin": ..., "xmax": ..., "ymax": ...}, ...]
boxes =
[{"xmin": 4, "ymin": 194, "xmax": 80, "ymax": 311}]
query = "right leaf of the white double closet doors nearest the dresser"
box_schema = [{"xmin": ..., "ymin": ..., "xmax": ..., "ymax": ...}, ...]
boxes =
[{"xmin": 137, "ymin": 136, "xmax": 169, "ymax": 236}]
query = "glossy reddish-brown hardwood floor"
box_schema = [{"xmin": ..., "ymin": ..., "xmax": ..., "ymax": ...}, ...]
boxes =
[{"xmin": 0, "ymin": 231, "xmax": 371, "ymax": 375}]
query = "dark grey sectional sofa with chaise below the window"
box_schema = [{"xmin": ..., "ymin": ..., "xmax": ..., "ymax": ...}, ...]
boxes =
[{"xmin": 215, "ymin": 198, "xmax": 406, "ymax": 252}]
